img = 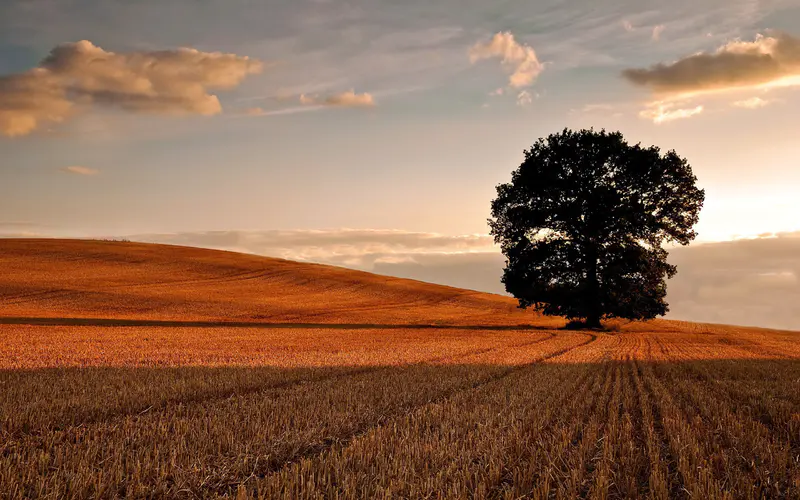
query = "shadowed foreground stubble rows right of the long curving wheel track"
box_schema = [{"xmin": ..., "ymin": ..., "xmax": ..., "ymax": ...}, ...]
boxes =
[{"xmin": 248, "ymin": 342, "xmax": 800, "ymax": 498}]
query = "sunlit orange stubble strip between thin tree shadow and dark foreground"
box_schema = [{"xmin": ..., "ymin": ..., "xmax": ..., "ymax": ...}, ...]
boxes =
[{"xmin": 0, "ymin": 325, "xmax": 564, "ymax": 370}]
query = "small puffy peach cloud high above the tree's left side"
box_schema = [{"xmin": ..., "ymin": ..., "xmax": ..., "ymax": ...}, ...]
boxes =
[{"xmin": 469, "ymin": 31, "xmax": 544, "ymax": 88}]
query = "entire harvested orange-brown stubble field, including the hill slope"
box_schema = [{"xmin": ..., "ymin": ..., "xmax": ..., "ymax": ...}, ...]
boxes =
[{"xmin": 0, "ymin": 240, "xmax": 800, "ymax": 499}]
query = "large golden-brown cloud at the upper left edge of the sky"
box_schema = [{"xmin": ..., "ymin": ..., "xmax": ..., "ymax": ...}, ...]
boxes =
[{"xmin": 0, "ymin": 40, "xmax": 262, "ymax": 137}]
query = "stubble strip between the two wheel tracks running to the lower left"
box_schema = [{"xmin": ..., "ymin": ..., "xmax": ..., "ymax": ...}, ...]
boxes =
[{"xmin": 0, "ymin": 334, "xmax": 586, "ymax": 497}]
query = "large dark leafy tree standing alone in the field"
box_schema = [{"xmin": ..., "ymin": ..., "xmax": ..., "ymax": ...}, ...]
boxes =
[{"xmin": 489, "ymin": 129, "xmax": 705, "ymax": 328}]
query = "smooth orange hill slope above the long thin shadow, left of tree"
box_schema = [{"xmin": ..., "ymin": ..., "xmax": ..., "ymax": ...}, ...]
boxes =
[{"xmin": 0, "ymin": 239, "xmax": 562, "ymax": 326}]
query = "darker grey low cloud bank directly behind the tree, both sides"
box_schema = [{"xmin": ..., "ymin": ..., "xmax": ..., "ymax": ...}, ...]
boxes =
[{"xmin": 373, "ymin": 232, "xmax": 800, "ymax": 330}]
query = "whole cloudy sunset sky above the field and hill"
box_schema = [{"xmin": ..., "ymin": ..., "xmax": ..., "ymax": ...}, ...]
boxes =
[{"xmin": 0, "ymin": 0, "xmax": 800, "ymax": 329}]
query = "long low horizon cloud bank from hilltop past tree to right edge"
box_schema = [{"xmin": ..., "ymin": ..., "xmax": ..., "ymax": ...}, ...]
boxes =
[{"xmin": 123, "ymin": 229, "xmax": 800, "ymax": 330}]
